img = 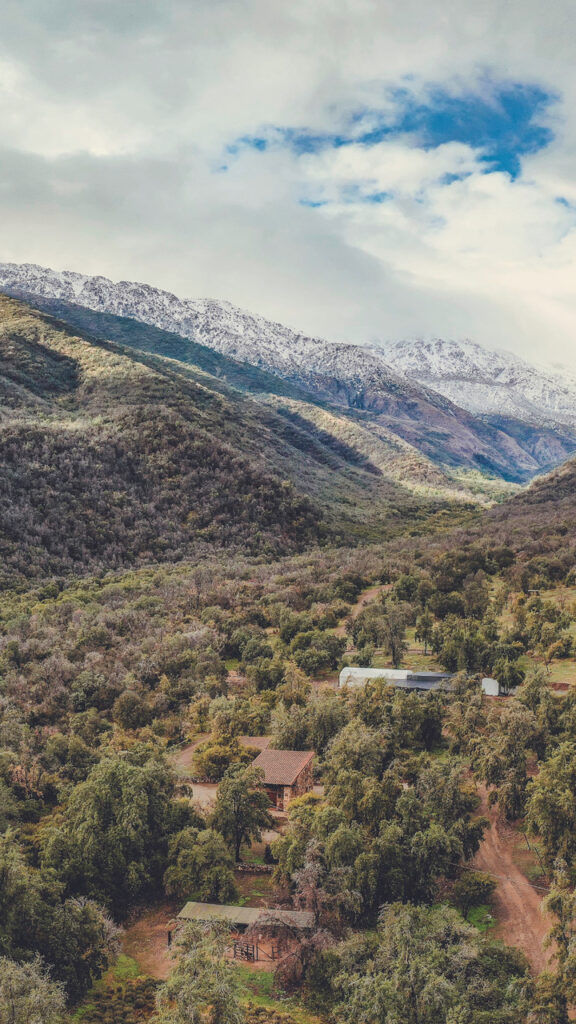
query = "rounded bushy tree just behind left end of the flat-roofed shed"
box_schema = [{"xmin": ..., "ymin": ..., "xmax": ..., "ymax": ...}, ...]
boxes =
[{"xmin": 164, "ymin": 828, "xmax": 238, "ymax": 903}]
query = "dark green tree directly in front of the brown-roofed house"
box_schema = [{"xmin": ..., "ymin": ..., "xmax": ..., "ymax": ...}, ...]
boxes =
[{"xmin": 212, "ymin": 765, "xmax": 274, "ymax": 862}]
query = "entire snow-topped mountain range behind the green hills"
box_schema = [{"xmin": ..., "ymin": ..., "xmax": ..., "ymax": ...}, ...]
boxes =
[{"xmin": 0, "ymin": 264, "xmax": 576, "ymax": 482}]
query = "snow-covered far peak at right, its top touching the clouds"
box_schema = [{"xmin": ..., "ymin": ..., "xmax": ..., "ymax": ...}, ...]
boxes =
[{"xmin": 382, "ymin": 338, "xmax": 576, "ymax": 427}]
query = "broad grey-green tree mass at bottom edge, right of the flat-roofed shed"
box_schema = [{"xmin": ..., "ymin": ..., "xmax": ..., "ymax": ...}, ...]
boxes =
[{"xmin": 325, "ymin": 904, "xmax": 530, "ymax": 1024}]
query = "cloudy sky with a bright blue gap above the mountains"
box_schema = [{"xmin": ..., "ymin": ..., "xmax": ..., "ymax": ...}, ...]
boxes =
[{"xmin": 0, "ymin": 0, "xmax": 576, "ymax": 368}]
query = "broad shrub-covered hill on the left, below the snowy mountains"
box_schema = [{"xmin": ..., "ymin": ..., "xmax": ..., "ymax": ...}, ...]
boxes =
[{"xmin": 0, "ymin": 297, "xmax": 473, "ymax": 583}]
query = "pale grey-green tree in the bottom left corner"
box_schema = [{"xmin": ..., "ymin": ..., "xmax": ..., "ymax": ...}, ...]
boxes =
[{"xmin": 0, "ymin": 956, "xmax": 66, "ymax": 1024}]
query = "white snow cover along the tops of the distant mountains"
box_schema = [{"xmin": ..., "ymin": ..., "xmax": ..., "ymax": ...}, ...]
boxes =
[{"xmin": 0, "ymin": 263, "xmax": 576, "ymax": 427}]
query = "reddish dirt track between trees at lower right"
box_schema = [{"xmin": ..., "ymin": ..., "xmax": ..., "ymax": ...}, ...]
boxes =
[{"xmin": 472, "ymin": 786, "xmax": 551, "ymax": 974}]
